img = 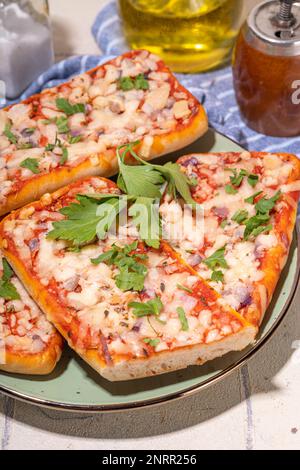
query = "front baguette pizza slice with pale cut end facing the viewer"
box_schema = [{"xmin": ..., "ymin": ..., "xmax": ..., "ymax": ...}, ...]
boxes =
[{"xmin": 0, "ymin": 177, "xmax": 257, "ymax": 381}]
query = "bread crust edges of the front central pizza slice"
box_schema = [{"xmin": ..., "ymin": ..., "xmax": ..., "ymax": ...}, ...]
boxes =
[{"xmin": 0, "ymin": 180, "xmax": 257, "ymax": 381}]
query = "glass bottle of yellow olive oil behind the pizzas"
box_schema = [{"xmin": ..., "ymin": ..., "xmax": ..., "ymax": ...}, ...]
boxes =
[{"xmin": 119, "ymin": 0, "xmax": 243, "ymax": 72}]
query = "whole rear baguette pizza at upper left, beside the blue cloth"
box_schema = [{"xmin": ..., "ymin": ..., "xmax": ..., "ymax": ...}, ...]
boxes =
[{"xmin": 0, "ymin": 47, "xmax": 207, "ymax": 216}]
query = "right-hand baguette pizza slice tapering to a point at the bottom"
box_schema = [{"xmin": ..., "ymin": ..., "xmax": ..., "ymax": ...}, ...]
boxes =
[{"xmin": 160, "ymin": 152, "xmax": 300, "ymax": 326}]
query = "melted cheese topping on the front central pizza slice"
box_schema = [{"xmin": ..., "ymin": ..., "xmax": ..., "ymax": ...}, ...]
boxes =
[{"xmin": 2, "ymin": 178, "xmax": 243, "ymax": 363}]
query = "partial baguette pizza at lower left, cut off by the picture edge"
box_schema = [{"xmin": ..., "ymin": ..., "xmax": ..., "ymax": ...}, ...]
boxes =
[{"xmin": 0, "ymin": 255, "xmax": 62, "ymax": 375}]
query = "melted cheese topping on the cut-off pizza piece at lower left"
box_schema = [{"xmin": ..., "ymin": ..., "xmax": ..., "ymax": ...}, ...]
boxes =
[{"xmin": 0, "ymin": 258, "xmax": 55, "ymax": 354}]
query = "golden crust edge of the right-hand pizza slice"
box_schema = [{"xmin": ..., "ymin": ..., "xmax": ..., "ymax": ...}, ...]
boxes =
[{"xmin": 173, "ymin": 152, "xmax": 300, "ymax": 326}]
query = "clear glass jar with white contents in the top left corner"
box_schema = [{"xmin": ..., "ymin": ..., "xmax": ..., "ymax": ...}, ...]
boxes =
[{"xmin": 0, "ymin": 0, "xmax": 54, "ymax": 99}]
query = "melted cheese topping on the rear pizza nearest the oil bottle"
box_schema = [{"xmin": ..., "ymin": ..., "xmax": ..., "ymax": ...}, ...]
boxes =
[{"xmin": 0, "ymin": 51, "xmax": 199, "ymax": 204}]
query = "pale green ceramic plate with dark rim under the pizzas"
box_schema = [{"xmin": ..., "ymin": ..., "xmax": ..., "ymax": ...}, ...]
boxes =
[{"xmin": 0, "ymin": 130, "xmax": 299, "ymax": 412}]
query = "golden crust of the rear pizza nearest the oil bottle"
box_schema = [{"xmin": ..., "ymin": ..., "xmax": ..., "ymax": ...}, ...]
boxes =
[{"xmin": 0, "ymin": 51, "xmax": 208, "ymax": 216}]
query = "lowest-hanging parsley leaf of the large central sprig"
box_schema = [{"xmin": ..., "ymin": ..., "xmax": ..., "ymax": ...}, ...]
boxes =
[{"xmin": 128, "ymin": 197, "xmax": 161, "ymax": 249}]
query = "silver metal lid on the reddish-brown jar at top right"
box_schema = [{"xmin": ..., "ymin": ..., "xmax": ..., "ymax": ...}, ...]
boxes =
[{"xmin": 244, "ymin": 0, "xmax": 300, "ymax": 57}]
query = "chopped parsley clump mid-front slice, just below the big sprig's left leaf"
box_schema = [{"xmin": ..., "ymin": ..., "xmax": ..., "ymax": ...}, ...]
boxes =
[{"xmin": 91, "ymin": 241, "xmax": 147, "ymax": 292}]
